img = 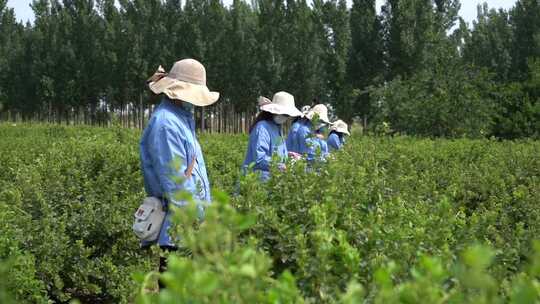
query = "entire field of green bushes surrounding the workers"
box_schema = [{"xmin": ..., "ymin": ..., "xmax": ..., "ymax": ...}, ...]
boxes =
[{"xmin": 0, "ymin": 124, "xmax": 540, "ymax": 303}]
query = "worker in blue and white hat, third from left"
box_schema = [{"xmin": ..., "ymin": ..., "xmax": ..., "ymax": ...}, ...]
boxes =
[{"xmin": 287, "ymin": 104, "xmax": 330, "ymax": 161}]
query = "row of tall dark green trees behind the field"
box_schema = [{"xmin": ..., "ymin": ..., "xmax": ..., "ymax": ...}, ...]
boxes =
[{"xmin": 0, "ymin": 0, "xmax": 540, "ymax": 138}]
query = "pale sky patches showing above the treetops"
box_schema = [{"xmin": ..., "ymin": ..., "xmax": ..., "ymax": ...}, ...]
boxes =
[{"xmin": 8, "ymin": 0, "xmax": 516, "ymax": 23}]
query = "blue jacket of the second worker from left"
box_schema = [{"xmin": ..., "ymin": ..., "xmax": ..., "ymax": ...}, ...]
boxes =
[{"xmin": 242, "ymin": 120, "xmax": 287, "ymax": 180}]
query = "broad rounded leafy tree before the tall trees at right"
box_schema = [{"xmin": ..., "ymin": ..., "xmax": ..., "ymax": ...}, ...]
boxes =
[{"xmin": 372, "ymin": 62, "xmax": 496, "ymax": 137}]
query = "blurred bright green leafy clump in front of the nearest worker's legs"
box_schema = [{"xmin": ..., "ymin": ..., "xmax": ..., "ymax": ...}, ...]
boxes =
[{"xmin": 138, "ymin": 193, "xmax": 302, "ymax": 303}]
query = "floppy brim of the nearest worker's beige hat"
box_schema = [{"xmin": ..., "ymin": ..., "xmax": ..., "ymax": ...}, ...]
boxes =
[{"xmin": 148, "ymin": 77, "xmax": 219, "ymax": 107}]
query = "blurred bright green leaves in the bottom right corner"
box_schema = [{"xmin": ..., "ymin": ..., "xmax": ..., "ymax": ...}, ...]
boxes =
[{"xmin": 358, "ymin": 243, "xmax": 540, "ymax": 304}]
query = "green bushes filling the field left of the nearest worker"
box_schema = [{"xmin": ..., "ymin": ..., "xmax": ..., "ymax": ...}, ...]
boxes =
[{"xmin": 0, "ymin": 125, "xmax": 156, "ymax": 303}]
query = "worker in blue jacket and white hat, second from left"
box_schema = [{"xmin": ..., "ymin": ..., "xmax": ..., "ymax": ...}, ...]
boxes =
[{"xmin": 242, "ymin": 92, "xmax": 302, "ymax": 181}]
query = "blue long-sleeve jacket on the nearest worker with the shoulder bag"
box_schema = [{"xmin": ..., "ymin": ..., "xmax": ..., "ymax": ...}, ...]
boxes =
[{"xmin": 140, "ymin": 98, "xmax": 211, "ymax": 246}]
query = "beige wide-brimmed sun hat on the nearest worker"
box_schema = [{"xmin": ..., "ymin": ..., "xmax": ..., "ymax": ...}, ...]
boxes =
[{"xmin": 148, "ymin": 59, "xmax": 219, "ymax": 107}]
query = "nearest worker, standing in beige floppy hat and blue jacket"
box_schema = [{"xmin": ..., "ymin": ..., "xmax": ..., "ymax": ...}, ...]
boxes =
[{"xmin": 140, "ymin": 59, "xmax": 219, "ymax": 278}]
